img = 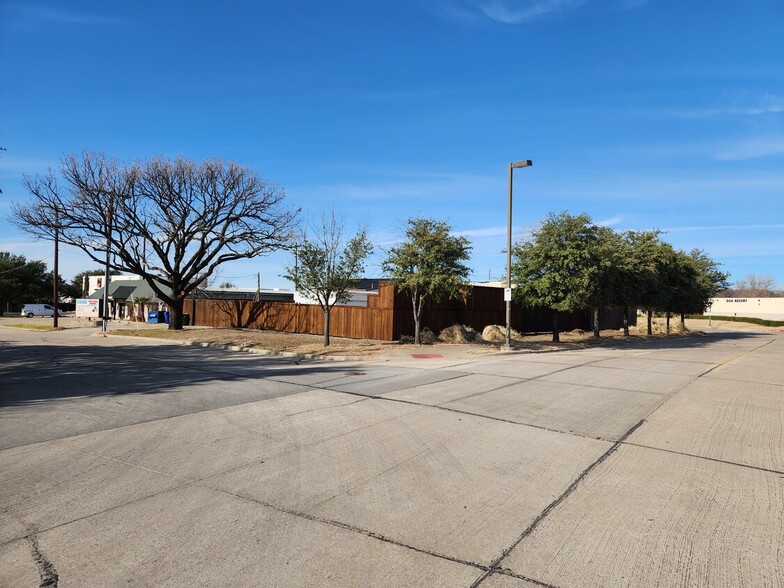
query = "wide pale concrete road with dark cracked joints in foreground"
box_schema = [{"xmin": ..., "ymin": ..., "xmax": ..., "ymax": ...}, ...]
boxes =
[{"xmin": 0, "ymin": 327, "xmax": 784, "ymax": 588}]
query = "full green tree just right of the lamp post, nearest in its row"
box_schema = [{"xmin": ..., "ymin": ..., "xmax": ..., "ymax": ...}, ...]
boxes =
[{"xmin": 512, "ymin": 212, "xmax": 606, "ymax": 342}]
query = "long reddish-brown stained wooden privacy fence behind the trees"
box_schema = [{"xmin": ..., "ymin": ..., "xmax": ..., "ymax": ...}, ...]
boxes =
[{"xmin": 185, "ymin": 282, "xmax": 636, "ymax": 341}]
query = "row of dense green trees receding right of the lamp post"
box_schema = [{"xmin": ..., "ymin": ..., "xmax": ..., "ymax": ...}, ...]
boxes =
[{"xmin": 512, "ymin": 212, "xmax": 728, "ymax": 341}]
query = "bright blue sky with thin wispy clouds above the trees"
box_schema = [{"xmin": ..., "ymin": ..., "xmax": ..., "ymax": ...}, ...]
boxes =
[{"xmin": 0, "ymin": 0, "xmax": 784, "ymax": 287}]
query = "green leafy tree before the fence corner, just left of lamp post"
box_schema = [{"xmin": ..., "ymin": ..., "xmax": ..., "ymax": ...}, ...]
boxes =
[{"xmin": 381, "ymin": 218, "xmax": 471, "ymax": 345}]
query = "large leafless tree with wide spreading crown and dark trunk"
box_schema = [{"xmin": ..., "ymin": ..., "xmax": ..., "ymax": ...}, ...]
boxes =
[{"xmin": 11, "ymin": 151, "xmax": 299, "ymax": 329}]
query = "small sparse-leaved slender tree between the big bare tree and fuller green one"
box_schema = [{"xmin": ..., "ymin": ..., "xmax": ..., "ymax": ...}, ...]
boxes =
[{"xmin": 285, "ymin": 211, "xmax": 373, "ymax": 347}]
